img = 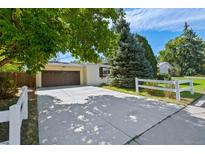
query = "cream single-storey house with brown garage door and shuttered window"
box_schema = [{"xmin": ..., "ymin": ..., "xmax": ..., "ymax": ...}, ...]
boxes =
[{"xmin": 36, "ymin": 63, "xmax": 109, "ymax": 87}]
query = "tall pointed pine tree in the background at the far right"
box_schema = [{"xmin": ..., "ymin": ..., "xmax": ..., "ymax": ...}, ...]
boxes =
[{"xmin": 178, "ymin": 23, "xmax": 205, "ymax": 75}]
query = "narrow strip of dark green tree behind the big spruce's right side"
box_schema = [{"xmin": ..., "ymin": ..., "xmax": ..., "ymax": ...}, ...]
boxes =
[{"xmin": 135, "ymin": 34, "xmax": 157, "ymax": 77}]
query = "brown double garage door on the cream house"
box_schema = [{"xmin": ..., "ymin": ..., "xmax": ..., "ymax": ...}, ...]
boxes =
[{"xmin": 42, "ymin": 71, "xmax": 80, "ymax": 87}]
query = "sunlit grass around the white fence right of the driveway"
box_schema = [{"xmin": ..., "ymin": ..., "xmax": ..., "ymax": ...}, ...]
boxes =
[{"xmin": 101, "ymin": 77, "xmax": 205, "ymax": 105}]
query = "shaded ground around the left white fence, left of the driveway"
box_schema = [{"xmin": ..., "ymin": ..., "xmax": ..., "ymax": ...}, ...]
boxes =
[{"xmin": 0, "ymin": 92, "xmax": 38, "ymax": 145}]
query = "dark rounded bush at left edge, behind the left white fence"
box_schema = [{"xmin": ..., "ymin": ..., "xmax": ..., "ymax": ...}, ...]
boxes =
[{"xmin": 0, "ymin": 77, "xmax": 18, "ymax": 99}]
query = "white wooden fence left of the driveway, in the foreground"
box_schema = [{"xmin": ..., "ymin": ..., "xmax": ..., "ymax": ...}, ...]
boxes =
[{"xmin": 0, "ymin": 86, "xmax": 28, "ymax": 145}]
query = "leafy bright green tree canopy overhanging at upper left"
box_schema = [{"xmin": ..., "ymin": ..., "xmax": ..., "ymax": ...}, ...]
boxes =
[{"xmin": 0, "ymin": 9, "xmax": 119, "ymax": 73}]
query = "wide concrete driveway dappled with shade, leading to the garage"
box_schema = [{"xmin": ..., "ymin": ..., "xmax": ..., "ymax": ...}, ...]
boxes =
[{"xmin": 36, "ymin": 86, "xmax": 181, "ymax": 144}]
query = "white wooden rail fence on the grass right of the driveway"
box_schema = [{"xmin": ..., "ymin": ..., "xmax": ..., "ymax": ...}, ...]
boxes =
[{"xmin": 135, "ymin": 78, "xmax": 194, "ymax": 101}]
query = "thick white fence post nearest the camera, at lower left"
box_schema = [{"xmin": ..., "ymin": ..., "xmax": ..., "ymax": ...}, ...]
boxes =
[{"xmin": 9, "ymin": 105, "xmax": 21, "ymax": 145}]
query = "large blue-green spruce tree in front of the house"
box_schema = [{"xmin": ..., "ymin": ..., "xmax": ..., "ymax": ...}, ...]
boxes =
[{"xmin": 109, "ymin": 18, "xmax": 152, "ymax": 88}]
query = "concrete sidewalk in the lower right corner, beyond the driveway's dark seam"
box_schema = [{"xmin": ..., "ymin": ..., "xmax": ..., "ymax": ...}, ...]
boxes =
[{"xmin": 129, "ymin": 96, "xmax": 205, "ymax": 145}]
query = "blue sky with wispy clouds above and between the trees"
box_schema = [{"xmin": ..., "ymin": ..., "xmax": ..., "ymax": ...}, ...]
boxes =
[{"xmin": 58, "ymin": 9, "xmax": 205, "ymax": 62}]
